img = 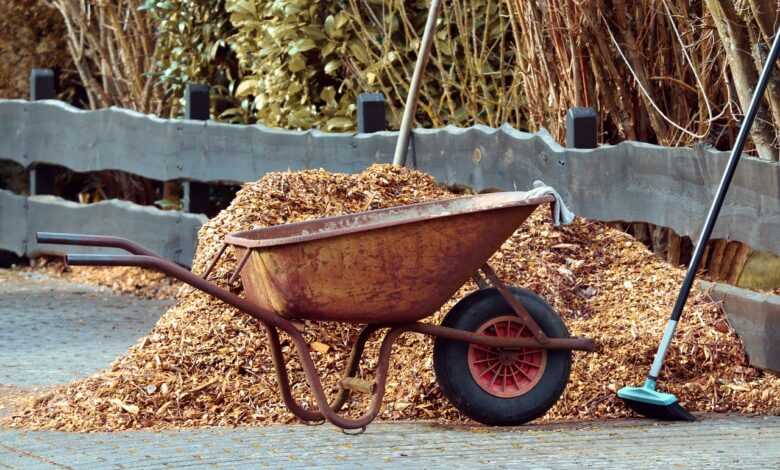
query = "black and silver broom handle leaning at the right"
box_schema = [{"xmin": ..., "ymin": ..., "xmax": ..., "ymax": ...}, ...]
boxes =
[{"xmin": 649, "ymin": 32, "xmax": 780, "ymax": 380}]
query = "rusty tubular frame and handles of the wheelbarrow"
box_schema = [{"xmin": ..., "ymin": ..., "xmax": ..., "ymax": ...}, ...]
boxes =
[{"xmin": 36, "ymin": 232, "xmax": 596, "ymax": 429}]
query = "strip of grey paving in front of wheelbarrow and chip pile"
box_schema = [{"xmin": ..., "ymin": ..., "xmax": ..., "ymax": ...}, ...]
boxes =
[{"xmin": 0, "ymin": 417, "xmax": 780, "ymax": 470}]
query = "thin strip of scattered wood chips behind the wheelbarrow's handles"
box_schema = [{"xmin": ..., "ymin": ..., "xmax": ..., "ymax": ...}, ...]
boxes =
[{"xmin": 32, "ymin": 257, "xmax": 184, "ymax": 299}]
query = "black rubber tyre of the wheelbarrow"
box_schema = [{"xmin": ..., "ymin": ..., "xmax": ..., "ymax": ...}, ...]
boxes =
[{"xmin": 433, "ymin": 287, "xmax": 571, "ymax": 426}]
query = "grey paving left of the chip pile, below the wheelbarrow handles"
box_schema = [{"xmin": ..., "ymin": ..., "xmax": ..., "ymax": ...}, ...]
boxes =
[{"xmin": 0, "ymin": 270, "xmax": 171, "ymax": 388}]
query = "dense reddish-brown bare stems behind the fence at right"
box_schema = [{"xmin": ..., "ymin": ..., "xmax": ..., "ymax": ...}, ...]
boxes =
[{"xmin": 505, "ymin": 0, "xmax": 780, "ymax": 160}]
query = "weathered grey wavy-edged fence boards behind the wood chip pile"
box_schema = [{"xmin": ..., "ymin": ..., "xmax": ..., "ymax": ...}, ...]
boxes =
[{"xmin": 0, "ymin": 100, "xmax": 780, "ymax": 263}]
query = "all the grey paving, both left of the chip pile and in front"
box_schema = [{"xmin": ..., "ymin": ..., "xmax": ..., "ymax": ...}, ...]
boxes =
[{"xmin": 0, "ymin": 270, "xmax": 780, "ymax": 469}]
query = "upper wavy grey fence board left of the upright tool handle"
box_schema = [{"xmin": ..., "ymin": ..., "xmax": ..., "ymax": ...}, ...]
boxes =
[{"xmin": 0, "ymin": 100, "xmax": 394, "ymax": 182}]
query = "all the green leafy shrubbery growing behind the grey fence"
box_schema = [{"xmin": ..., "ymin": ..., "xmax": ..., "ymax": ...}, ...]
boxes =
[{"xmin": 145, "ymin": 0, "xmax": 525, "ymax": 131}]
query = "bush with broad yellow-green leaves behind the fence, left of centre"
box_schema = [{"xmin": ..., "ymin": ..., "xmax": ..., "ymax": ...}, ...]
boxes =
[{"xmin": 226, "ymin": 0, "xmax": 355, "ymax": 131}]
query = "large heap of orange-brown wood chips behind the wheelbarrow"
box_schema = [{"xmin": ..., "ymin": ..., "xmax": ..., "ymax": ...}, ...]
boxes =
[{"xmin": 7, "ymin": 165, "xmax": 780, "ymax": 431}]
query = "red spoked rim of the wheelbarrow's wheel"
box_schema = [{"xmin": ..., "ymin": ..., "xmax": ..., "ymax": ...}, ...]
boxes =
[{"xmin": 468, "ymin": 315, "xmax": 547, "ymax": 398}]
